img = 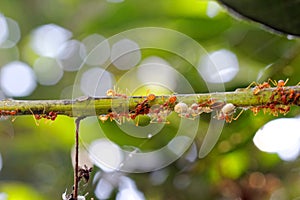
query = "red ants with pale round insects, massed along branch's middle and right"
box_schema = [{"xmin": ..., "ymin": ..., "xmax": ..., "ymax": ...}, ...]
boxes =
[{"xmin": 99, "ymin": 79, "xmax": 300, "ymax": 126}]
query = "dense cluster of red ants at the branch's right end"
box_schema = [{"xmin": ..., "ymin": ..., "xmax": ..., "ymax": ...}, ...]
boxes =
[{"xmin": 248, "ymin": 79, "xmax": 300, "ymax": 116}]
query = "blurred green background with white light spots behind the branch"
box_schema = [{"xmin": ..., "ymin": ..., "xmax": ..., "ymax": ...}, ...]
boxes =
[{"xmin": 0, "ymin": 0, "xmax": 300, "ymax": 200}]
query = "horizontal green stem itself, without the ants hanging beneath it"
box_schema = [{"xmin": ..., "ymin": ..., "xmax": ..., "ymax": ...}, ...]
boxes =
[{"xmin": 0, "ymin": 86, "xmax": 300, "ymax": 117}]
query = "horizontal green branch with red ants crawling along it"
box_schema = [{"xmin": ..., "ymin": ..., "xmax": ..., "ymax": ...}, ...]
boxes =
[{"xmin": 0, "ymin": 86, "xmax": 300, "ymax": 120}]
